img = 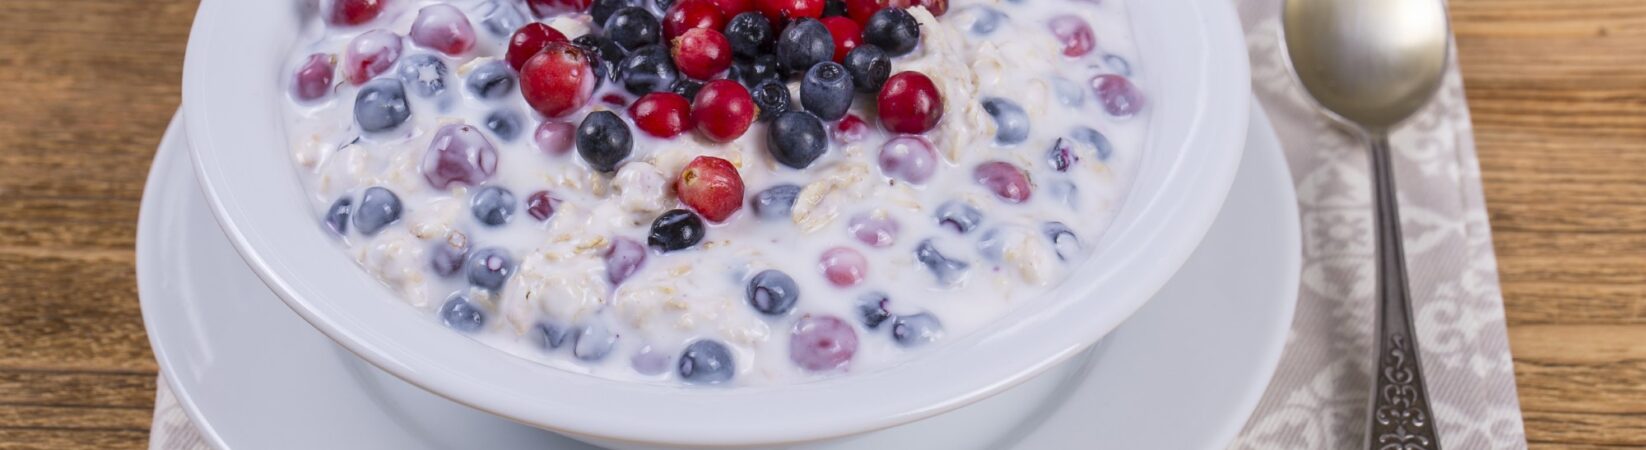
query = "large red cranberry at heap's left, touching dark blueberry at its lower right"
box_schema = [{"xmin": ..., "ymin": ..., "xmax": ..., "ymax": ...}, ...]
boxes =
[{"xmin": 520, "ymin": 43, "xmax": 596, "ymax": 117}]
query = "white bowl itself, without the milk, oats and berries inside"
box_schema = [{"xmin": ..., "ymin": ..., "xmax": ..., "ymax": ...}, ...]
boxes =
[{"xmin": 183, "ymin": 0, "xmax": 1249, "ymax": 447}]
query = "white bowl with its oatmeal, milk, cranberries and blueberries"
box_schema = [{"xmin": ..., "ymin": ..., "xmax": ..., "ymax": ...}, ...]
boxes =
[{"xmin": 184, "ymin": 0, "xmax": 1249, "ymax": 447}]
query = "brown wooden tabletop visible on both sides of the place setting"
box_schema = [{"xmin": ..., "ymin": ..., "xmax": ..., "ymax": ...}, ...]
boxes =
[{"xmin": 0, "ymin": 0, "xmax": 1646, "ymax": 448}]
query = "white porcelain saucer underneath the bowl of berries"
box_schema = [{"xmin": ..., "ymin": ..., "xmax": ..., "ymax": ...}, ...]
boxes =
[{"xmin": 137, "ymin": 101, "xmax": 1300, "ymax": 448}]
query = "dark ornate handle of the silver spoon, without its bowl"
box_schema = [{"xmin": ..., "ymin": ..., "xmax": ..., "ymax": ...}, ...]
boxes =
[{"xmin": 1366, "ymin": 134, "xmax": 1440, "ymax": 450}]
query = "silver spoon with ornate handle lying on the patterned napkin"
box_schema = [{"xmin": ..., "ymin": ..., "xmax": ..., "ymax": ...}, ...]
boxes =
[{"xmin": 1282, "ymin": 0, "xmax": 1450, "ymax": 450}]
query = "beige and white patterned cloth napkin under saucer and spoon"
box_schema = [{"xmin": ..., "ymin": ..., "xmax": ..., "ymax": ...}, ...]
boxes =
[{"xmin": 150, "ymin": 0, "xmax": 1526, "ymax": 450}]
